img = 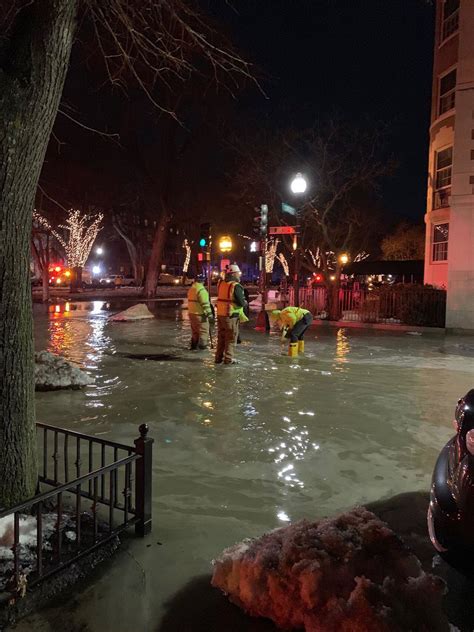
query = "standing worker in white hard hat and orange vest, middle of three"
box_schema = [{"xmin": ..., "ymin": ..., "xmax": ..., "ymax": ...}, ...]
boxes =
[{"xmin": 215, "ymin": 264, "xmax": 248, "ymax": 364}]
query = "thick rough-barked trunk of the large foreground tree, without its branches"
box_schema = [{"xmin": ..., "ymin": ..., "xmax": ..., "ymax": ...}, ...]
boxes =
[{"xmin": 0, "ymin": 0, "xmax": 77, "ymax": 507}]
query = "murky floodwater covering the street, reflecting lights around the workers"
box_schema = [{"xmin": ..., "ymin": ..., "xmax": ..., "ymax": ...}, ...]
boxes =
[{"xmin": 23, "ymin": 302, "xmax": 474, "ymax": 632}]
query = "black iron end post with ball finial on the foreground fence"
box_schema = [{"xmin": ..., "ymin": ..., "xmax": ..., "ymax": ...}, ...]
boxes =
[{"xmin": 134, "ymin": 424, "xmax": 153, "ymax": 537}]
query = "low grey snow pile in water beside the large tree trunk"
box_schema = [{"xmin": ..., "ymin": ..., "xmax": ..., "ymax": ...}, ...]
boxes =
[{"xmin": 35, "ymin": 351, "xmax": 94, "ymax": 391}]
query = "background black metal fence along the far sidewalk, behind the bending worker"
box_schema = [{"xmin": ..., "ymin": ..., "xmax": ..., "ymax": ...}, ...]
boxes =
[{"xmin": 289, "ymin": 285, "xmax": 446, "ymax": 327}]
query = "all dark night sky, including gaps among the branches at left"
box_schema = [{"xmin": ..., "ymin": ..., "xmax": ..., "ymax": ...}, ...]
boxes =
[{"xmin": 46, "ymin": 0, "xmax": 434, "ymax": 230}]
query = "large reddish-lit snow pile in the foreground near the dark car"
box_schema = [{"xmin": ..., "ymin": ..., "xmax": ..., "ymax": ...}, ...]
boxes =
[{"xmin": 212, "ymin": 508, "xmax": 449, "ymax": 632}]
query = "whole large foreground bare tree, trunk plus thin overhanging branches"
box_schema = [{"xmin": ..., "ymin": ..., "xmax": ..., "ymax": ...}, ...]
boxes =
[{"xmin": 0, "ymin": 0, "xmax": 254, "ymax": 506}]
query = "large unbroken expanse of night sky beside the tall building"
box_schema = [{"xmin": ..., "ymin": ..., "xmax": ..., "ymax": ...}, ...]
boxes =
[{"xmin": 206, "ymin": 0, "xmax": 434, "ymax": 223}]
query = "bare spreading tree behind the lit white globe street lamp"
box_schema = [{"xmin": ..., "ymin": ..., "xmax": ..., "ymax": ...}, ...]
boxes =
[{"xmin": 234, "ymin": 119, "xmax": 393, "ymax": 319}]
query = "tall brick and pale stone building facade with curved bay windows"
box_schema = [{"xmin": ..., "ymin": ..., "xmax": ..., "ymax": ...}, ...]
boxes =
[{"xmin": 425, "ymin": 0, "xmax": 474, "ymax": 330}]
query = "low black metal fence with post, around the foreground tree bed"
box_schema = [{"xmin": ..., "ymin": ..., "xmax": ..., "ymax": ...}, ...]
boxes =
[{"xmin": 0, "ymin": 423, "xmax": 153, "ymax": 592}]
